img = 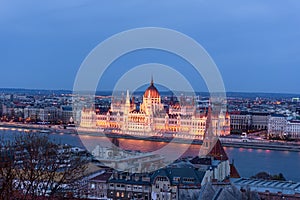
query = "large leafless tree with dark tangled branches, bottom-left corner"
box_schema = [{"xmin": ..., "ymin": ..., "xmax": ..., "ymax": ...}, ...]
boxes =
[{"xmin": 0, "ymin": 133, "xmax": 88, "ymax": 199}]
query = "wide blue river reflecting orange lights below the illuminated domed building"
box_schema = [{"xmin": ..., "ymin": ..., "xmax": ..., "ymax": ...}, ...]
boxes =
[{"xmin": 0, "ymin": 129, "xmax": 300, "ymax": 182}]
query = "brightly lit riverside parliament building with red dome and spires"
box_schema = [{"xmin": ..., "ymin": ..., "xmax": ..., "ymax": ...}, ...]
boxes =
[{"xmin": 80, "ymin": 80, "xmax": 230, "ymax": 139}]
